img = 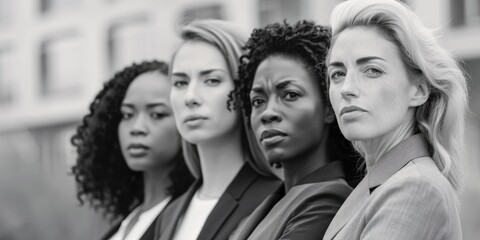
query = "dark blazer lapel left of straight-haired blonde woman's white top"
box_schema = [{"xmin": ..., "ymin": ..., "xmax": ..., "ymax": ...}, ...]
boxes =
[{"xmin": 158, "ymin": 180, "xmax": 201, "ymax": 240}]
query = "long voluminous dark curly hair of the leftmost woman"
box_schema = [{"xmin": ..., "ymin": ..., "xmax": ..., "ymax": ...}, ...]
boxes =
[{"xmin": 71, "ymin": 61, "xmax": 193, "ymax": 219}]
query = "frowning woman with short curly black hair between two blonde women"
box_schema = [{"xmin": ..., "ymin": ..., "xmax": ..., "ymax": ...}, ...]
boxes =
[{"xmin": 232, "ymin": 21, "xmax": 355, "ymax": 240}]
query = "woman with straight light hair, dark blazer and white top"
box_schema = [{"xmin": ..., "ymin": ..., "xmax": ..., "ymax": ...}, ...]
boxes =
[{"xmin": 157, "ymin": 20, "xmax": 280, "ymax": 240}]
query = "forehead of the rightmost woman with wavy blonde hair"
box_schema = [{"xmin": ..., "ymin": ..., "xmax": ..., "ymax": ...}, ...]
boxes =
[{"xmin": 329, "ymin": 26, "xmax": 400, "ymax": 62}]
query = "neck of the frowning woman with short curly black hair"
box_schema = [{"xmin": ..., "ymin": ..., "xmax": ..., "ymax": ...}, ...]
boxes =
[{"xmin": 282, "ymin": 127, "xmax": 328, "ymax": 192}]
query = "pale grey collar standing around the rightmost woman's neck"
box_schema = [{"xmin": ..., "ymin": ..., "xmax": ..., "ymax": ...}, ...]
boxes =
[{"xmin": 367, "ymin": 134, "xmax": 430, "ymax": 189}]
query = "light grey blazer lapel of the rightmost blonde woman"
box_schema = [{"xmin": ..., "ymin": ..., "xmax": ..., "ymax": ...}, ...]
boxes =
[{"xmin": 323, "ymin": 177, "xmax": 370, "ymax": 240}]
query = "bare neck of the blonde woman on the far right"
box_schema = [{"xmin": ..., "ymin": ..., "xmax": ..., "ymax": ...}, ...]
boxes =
[{"xmin": 359, "ymin": 113, "xmax": 414, "ymax": 171}]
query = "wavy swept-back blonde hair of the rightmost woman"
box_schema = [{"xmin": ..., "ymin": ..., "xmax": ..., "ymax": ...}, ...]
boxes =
[{"xmin": 327, "ymin": 0, "xmax": 468, "ymax": 192}]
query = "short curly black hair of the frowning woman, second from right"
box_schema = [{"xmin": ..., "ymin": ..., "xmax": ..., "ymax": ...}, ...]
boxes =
[{"xmin": 233, "ymin": 20, "xmax": 362, "ymax": 185}]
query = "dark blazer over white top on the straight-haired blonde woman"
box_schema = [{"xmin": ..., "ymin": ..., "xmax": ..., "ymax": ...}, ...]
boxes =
[{"xmin": 155, "ymin": 164, "xmax": 281, "ymax": 240}]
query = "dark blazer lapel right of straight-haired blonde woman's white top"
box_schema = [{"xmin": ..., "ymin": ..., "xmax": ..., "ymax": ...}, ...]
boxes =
[{"xmin": 197, "ymin": 163, "xmax": 257, "ymax": 240}]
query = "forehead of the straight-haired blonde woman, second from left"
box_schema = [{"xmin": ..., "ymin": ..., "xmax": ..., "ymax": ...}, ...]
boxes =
[{"xmin": 172, "ymin": 41, "xmax": 227, "ymax": 73}]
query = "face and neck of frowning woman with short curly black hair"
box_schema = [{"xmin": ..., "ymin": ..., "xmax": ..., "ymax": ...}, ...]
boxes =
[{"xmin": 250, "ymin": 55, "xmax": 333, "ymax": 192}]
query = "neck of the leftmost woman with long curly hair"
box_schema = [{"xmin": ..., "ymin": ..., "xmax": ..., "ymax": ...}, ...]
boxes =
[{"xmin": 143, "ymin": 167, "xmax": 172, "ymax": 210}]
